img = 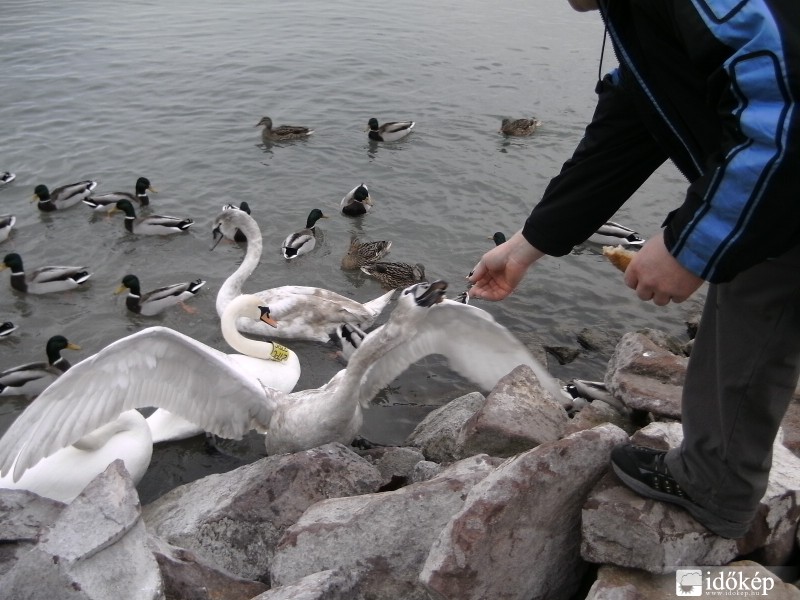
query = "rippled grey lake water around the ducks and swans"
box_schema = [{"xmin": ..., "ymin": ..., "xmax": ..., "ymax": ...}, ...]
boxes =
[{"xmin": 0, "ymin": 0, "xmax": 696, "ymax": 502}]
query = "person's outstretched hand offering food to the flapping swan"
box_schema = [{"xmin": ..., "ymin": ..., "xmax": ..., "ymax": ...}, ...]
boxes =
[{"xmin": 467, "ymin": 231, "xmax": 544, "ymax": 300}]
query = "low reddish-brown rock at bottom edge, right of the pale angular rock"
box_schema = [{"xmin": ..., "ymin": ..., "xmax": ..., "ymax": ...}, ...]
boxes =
[{"xmin": 148, "ymin": 536, "xmax": 269, "ymax": 600}]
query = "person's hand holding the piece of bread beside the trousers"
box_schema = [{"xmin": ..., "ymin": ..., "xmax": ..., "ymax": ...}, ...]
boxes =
[{"xmin": 625, "ymin": 235, "xmax": 703, "ymax": 306}]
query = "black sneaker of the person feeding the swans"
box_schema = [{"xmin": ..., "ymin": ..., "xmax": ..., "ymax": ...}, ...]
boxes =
[{"xmin": 611, "ymin": 444, "xmax": 750, "ymax": 539}]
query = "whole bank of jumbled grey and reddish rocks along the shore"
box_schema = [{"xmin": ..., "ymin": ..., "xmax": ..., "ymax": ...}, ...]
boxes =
[{"xmin": 0, "ymin": 331, "xmax": 800, "ymax": 600}]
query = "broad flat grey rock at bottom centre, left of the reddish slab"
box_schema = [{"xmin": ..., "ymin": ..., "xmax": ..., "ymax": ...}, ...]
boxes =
[{"xmin": 271, "ymin": 456, "xmax": 500, "ymax": 600}]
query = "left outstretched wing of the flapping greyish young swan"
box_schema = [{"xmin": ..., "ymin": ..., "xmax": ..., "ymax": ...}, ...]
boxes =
[{"xmin": 0, "ymin": 327, "xmax": 274, "ymax": 480}]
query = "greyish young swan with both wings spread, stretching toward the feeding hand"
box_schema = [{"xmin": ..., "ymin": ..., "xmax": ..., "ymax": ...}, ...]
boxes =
[{"xmin": 0, "ymin": 282, "xmax": 563, "ymax": 481}]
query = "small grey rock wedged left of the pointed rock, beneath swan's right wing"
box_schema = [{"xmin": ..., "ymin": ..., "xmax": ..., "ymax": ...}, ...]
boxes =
[{"xmin": 406, "ymin": 392, "xmax": 486, "ymax": 463}]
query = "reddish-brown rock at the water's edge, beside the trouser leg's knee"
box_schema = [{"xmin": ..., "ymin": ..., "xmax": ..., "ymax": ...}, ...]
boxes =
[{"xmin": 605, "ymin": 333, "xmax": 688, "ymax": 419}]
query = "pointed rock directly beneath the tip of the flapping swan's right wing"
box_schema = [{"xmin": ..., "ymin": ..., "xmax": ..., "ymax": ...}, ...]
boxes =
[{"xmin": 456, "ymin": 365, "xmax": 569, "ymax": 457}]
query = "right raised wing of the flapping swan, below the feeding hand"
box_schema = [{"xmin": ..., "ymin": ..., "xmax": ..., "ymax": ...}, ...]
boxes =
[{"xmin": 348, "ymin": 300, "xmax": 561, "ymax": 405}]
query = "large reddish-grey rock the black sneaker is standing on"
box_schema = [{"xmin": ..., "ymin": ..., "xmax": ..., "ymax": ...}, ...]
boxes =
[{"xmin": 581, "ymin": 423, "xmax": 800, "ymax": 573}]
